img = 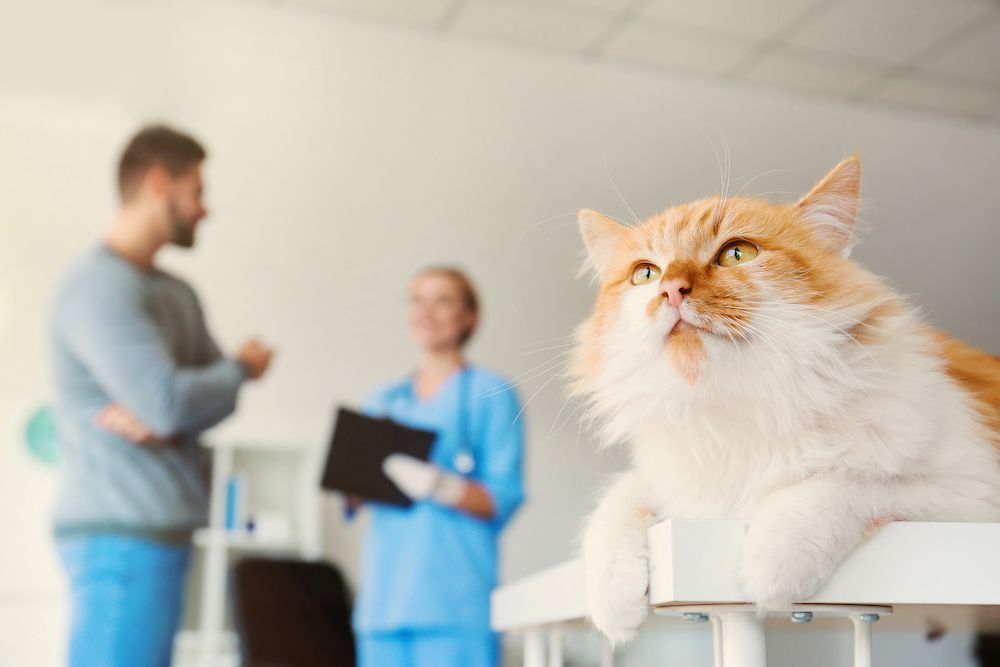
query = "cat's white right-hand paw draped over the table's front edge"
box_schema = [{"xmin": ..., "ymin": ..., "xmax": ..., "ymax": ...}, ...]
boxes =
[{"xmin": 740, "ymin": 523, "xmax": 839, "ymax": 611}]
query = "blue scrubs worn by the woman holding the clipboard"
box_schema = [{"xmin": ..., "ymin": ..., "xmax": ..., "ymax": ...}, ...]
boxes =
[{"xmin": 354, "ymin": 368, "xmax": 524, "ymax": 667}]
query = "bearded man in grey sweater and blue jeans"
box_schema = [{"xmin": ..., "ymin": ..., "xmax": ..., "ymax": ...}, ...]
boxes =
[{"xmin": 52, "ymin": 127, "xmax": 271, "ymax": 667}]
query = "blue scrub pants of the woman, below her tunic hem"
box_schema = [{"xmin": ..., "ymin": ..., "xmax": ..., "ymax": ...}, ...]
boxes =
[{"xmin": 357, "ymin": 629, "xmax": 499, "ymax": 667}]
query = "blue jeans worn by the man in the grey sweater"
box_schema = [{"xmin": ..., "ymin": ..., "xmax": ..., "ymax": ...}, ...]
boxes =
[{"xmin": 58, "ymin": 535, "xmax": 190, "ymax": 667}]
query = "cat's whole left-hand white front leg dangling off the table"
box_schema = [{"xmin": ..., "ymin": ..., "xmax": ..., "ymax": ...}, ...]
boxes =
[{"xmin": 583, "ymin": 472, "xmax": 656, "ymax": 644}]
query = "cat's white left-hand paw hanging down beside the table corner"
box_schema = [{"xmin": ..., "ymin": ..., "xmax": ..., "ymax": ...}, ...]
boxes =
[{"xmin": 583, "ymin": 531, "xmax": 649, "ymax": 644}]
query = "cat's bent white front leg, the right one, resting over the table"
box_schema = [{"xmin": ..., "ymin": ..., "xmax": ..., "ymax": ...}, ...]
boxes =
[{"xmin": 740, "ymin": 476, "xmax": 880, "ymax": 611}]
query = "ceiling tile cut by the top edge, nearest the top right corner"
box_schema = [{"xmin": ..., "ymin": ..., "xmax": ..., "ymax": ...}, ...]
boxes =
[{"xmin": 788, "ymin": 0, "xmax": 995, "ymax": 64}]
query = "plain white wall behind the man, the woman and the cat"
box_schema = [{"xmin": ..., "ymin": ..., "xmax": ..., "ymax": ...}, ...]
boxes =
[{"xmin": 0, "ymin": 0, "xmax": 1000, "ymax": 665}]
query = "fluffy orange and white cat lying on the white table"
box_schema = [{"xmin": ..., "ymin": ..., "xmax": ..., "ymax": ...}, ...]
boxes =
[{"xmin": 573, "ymin": 156, "xmax": 1000, "ymax": 642}]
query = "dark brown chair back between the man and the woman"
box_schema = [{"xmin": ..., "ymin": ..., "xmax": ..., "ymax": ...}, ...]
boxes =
[{"xmin": 232, "ymin": 558, "xmax": 355, "ymax": 667}]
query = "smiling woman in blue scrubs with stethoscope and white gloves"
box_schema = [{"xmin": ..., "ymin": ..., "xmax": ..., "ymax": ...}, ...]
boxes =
[{"xmin": 354, "ymin": 268, "xmax": 523, "ymax": 667}]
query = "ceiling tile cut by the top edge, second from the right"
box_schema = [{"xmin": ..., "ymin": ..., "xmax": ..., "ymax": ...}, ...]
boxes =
[{"xmin": 642, "ymin": 0, "xmax": 816, "ymax": 40}]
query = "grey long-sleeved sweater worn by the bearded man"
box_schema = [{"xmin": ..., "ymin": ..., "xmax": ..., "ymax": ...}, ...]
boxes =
[{"xmin": 51, "ymin": 246, "xmax": 246, "ymax": 543}]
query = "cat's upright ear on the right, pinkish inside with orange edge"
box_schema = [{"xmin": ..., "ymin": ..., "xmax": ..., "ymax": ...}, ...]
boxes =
[{"xmin": 798, "ymin": 153, "xmax": 861, "ymax": 257}]
